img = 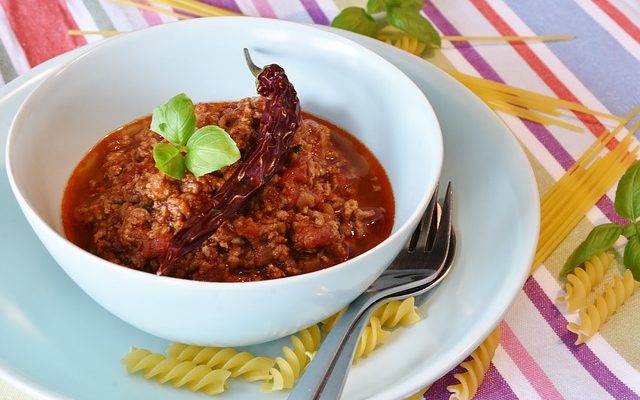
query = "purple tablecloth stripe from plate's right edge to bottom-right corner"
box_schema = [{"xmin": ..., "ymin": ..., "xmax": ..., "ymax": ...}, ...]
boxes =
[{"xmin": 524, "ymin": 277, "xmax": 640, "ymax": 400}]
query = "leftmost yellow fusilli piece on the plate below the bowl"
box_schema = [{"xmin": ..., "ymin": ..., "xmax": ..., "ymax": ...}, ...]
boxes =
[{"xmin": 122, "ymin": 347, "xmax": 231, "ymax": 395}]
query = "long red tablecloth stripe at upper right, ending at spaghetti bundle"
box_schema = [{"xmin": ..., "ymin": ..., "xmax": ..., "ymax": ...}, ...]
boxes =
[{"xmin": 471, "ymin": 0, "xmax": 618, "ymax": 149}]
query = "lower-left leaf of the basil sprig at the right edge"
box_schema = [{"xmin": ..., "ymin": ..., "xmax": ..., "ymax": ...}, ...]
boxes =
[{"xmin": 560, "ymin": 224, "xmax": 622, "ymax": 279}]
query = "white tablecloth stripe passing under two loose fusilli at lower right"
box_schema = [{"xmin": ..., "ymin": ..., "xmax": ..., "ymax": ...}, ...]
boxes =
[{"xmin": 534, "ymin": 268, "xmax": 640, "ymax": 395}]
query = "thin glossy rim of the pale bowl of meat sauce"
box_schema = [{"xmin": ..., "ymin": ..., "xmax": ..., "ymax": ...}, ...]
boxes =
[{"xmin": 5, "ymin": 16, "xmax": 444, "ymax": 290}]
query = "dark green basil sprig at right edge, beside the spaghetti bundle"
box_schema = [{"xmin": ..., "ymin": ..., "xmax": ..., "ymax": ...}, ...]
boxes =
[{"xmin": 560, "ymin": 161, "xmax": 640, "ymax": 281}]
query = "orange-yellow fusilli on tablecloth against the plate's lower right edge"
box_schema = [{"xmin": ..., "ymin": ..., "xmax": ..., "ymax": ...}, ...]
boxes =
[{"xmin": 447, "ymin": 326, "xmax": 500, "ymax": 400}]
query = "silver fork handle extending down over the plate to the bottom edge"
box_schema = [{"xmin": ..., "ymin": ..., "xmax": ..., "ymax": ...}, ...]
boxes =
[{"xmin": 287, "ymin": 294, "xmax": 377, "ymax": 400}]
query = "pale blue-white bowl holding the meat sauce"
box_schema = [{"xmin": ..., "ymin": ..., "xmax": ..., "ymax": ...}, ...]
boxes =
[{"xmin": 6, "ymin": 17, "xmax": 443, "ymax": 346}]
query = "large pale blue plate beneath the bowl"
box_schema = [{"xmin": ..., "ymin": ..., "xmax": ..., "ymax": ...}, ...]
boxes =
[{"xmin": 0, "ymin": 28, "xmax": 539, "ymax": 400}]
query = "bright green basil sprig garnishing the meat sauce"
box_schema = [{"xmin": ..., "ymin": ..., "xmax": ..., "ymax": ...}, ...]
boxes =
[{"xmin": 151, "ymin": 93, "xmax": 240, "ymax": 179}]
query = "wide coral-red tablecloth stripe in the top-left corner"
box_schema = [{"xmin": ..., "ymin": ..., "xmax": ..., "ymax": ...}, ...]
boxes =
[{"xmin": 0, "ymin": 0, "xmax": 87, "ymax": 67}]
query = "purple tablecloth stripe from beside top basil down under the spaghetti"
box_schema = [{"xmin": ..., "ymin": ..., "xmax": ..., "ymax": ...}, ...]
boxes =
[{"xmin": 423, "ymin": 0, "xmax": 624, "ymax": 222}]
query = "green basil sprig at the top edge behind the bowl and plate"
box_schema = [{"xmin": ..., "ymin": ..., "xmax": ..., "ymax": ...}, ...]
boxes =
[{"xmin": 331, "ymin": 0, "xmax": 442, "ymax": 47}]
